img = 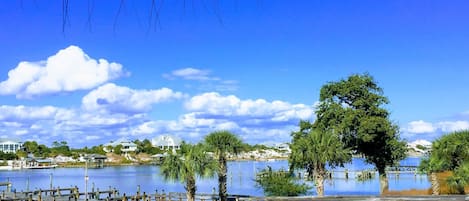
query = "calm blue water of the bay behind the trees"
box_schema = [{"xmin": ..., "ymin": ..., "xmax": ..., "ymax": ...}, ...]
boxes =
[{"xmin": 0, "ymin": 158, "xmax": 430, "ymax": 196}]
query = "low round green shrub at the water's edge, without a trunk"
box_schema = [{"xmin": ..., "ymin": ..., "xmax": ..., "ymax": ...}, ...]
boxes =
[{"xmin": 255, "ymin": 166, "xmax": 311, "ymax": 196}]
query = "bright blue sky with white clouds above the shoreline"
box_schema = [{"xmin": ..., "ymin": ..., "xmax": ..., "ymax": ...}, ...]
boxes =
[{"xmin": 0, "ymin": 0, "xmax": 469, "ymax": 147}]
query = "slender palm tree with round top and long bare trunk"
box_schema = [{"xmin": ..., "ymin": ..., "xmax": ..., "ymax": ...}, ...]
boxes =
[{"xmin": 205, "ymin": 131, "xmax": 242, "ymax": 201}]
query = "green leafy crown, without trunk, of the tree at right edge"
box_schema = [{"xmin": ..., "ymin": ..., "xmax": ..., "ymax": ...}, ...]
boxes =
[{"xmin": 419, "ymin": 130, "xmax": 469, "ymax": 173}]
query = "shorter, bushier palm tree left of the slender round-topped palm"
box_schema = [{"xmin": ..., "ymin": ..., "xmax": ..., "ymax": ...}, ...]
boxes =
[{"xmin": 160, "ymin": 144, "xmax": 217, "ymax": 201}]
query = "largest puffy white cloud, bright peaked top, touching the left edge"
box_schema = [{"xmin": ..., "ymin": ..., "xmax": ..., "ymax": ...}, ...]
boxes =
[{"xmin": 0, "ymin": 46, "xmax": 125, "ymax": 98}]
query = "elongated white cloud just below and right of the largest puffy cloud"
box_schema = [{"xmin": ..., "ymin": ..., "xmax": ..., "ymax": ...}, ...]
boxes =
[{"xmin": 82, "ymin": 83, "xmax": 185, "ymax": 113}]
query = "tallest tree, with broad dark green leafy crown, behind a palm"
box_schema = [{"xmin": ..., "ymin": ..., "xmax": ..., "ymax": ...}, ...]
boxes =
[{"xmin": 313, "ymin": 74, "xmax": 406, "ymax": 192}]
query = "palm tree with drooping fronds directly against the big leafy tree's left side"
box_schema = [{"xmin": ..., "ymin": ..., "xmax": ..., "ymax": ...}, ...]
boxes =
[{"xmin": 289, "ymin": 121, "xmax": 352, "ymax": 196}]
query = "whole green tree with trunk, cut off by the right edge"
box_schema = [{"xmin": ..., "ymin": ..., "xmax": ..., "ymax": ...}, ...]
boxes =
[{"xmin": 419, "ymin": 130, "xmax": 469, "ymax": 195}]
